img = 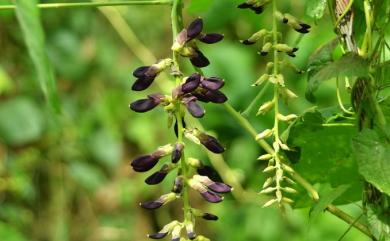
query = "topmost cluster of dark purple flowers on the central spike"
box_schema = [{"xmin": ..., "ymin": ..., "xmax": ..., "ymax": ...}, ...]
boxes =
[{"xmin": 172, "ymin": 18, "xmax": 224, "ymax": 68}]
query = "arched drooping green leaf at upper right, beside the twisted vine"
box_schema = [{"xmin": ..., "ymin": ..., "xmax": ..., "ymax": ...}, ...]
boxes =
[{"xmin": 306, "ymin": 53, "xmax": 369, "ymax": 101}]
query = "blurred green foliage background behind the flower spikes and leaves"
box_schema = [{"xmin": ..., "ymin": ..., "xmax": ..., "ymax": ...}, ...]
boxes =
[{"xmin": 0, "ymin": 0, "xmax": 368, "ymax": 241}]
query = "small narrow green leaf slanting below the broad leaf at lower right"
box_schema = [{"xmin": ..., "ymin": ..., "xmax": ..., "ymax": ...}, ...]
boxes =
[{"xmin": 310, "ymin": 185, "xmax": 351, "ymax": 219}]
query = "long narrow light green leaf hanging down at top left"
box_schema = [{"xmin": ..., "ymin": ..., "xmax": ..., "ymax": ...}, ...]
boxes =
[{"xmin": 15, "ymin": 0, "xmax": 60, "ymax": 113}]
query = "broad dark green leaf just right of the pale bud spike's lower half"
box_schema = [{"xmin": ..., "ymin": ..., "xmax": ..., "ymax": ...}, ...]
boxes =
[{"xmin": 288, "ymin": 111, "xmax": 362, "ymax": 203}]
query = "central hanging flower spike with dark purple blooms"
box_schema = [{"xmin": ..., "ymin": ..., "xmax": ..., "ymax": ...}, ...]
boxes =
[{"xmin": 130, "ymin": 18, "xmax": 232, "ymax": 241}]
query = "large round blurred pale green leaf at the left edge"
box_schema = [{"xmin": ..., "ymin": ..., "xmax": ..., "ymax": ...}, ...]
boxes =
[{"xmin": 0, "ymin": 98, "xmax": 45, "ymax": 145}]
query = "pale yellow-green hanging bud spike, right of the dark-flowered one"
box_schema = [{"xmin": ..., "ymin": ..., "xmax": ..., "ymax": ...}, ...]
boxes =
[{"xmin": 238, "ymin": 0, "xmax": 311, "ymax": 207}]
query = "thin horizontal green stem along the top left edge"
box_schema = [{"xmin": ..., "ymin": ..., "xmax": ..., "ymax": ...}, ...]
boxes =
[{"xmin": 0, "ymin": 0, "xmax": 172, "ymax": 10}]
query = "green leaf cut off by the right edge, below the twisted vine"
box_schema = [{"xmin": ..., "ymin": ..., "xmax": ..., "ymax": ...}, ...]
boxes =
[{"xmin": 353, "ymin": 129, "xmax": 390, "ymax": 195}]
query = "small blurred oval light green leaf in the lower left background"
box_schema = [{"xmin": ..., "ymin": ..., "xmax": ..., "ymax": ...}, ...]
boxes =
[{"xmin": 70, "ymin": 162, "xmax": 105, "ymax": 191}]
